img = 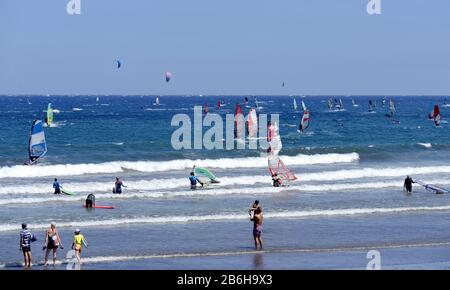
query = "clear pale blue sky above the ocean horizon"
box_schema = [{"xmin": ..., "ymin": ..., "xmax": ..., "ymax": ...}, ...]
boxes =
[{"xmin": 0, "ymin": 0, "xmax": 450, "ymax": 95}]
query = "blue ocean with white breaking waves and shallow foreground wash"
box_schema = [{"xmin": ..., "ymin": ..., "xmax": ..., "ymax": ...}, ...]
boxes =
[{"xmin": 0, "ymin": 95, "xmax": 450, "ymax": 269}]
